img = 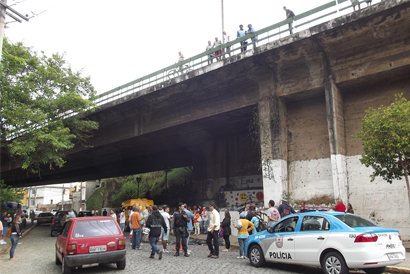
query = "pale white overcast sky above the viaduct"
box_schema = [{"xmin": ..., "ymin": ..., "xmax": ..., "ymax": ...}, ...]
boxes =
[{"xmin": 5, "ymin": 0, "xmax": 380, "ymax": 94}]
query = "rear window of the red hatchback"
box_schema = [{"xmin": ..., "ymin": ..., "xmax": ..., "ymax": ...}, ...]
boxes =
[{"xmin": 73, "ymin": 219, "xmax": 120, "ymax": 238}]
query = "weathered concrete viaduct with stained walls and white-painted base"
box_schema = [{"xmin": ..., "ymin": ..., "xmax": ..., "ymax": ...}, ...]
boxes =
[{"xmin": 1, "ymin": 0, "xmax": 410, "ymax": 237}]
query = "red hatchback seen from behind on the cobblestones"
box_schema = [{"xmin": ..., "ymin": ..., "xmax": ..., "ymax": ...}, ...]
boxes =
[{"xmin": 55, "ymin": 217, "xmax": 126, "ymax": 274}]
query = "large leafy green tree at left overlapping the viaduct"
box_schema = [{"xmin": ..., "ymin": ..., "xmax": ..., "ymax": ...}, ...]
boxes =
[{"xmin": 0, "ymin": 39, "xmax": 98, "ymax": 175}]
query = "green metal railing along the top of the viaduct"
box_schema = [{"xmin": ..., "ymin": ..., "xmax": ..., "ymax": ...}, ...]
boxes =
[{"xmin": 95, "ymin": 0, "xmax": 380, "ymax": 105}]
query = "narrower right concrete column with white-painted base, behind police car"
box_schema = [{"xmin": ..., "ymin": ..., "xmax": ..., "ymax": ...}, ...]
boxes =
[{"xmin": 325, "ymin": 76, "xmax": 349, "ymax": 204}]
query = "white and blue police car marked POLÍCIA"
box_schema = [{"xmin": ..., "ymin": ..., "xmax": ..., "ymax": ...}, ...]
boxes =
[{"xmin": 245, "ymin": 212, "xmax": 406, "ymax": 274}]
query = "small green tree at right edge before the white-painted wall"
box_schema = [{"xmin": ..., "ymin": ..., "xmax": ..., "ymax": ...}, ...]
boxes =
[{"xmin": 356, "ymin": 94, "xmax": 410, "ymax": 207}]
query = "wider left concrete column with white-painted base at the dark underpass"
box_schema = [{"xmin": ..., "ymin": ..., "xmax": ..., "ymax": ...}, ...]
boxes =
[{"xmin": 258, "ymin": 95, "xmax": 288, "ymax": 206}]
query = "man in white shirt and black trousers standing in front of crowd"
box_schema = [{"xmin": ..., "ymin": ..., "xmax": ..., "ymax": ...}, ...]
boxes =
[{"xmin": 206, "ymin": 203, "xmax": 221, "ymax": 259}]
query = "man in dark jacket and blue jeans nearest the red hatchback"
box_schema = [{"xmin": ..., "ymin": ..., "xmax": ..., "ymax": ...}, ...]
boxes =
[{"xmin": 146, "ymin": 205, "xmax": 167, "ymax": 260}]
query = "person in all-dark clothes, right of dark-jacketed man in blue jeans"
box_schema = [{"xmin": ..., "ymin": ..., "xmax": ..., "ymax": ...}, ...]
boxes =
[{"xmin": 171, "ymin": 203, "xmax": 189, "ymax": 257}]
